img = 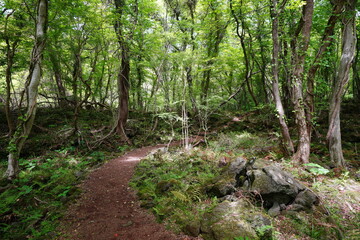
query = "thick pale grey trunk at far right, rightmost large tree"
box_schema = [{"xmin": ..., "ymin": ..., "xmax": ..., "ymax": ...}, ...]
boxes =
[{"xmin": 326, "ymin": 0, "xmax": 356, "ymax": 168}]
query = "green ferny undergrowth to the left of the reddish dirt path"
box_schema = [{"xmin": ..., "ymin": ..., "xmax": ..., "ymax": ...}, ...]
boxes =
[{"xmin": 0, "ymin": 148, "xmax": 114, "ymax": 240}]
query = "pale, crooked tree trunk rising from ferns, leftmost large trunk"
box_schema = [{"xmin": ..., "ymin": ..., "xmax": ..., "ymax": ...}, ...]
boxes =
[{"xmin": 5, "ymin": 0, "xmax": 48, "ymax": 179}]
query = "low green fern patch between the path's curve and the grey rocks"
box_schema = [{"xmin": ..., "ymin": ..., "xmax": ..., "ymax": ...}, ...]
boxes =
[{"xmin": 130, "ymin": 150, "xmax": 219, "ymax": 231}]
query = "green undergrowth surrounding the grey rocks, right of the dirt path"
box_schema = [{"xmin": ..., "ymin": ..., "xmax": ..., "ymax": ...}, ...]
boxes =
[{"xmin": 131, "ymin": 131, "xmax": 360, "ymax": 240}]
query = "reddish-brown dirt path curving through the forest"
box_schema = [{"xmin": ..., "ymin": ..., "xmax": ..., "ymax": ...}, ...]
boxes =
[{"xmin": 57, "ymin": 142, "xmax": 201, "ymax": 240}]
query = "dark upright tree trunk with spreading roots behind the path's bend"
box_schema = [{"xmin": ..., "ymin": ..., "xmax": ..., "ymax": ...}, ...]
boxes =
[{"xmin": 114, "ymin": 0, "xmax": 130, "ymax": 144}]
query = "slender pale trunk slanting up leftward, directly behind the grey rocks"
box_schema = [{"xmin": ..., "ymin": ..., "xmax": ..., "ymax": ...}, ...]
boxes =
[{"xmin": 270, "ymin": 0, "xmax": 294, "ymax": 156}]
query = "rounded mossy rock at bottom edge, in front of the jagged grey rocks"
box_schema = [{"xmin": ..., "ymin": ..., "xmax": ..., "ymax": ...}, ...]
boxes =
[{"xmin": 200, "ymin": 199, "xmax": 271, "ymax": 240}]
